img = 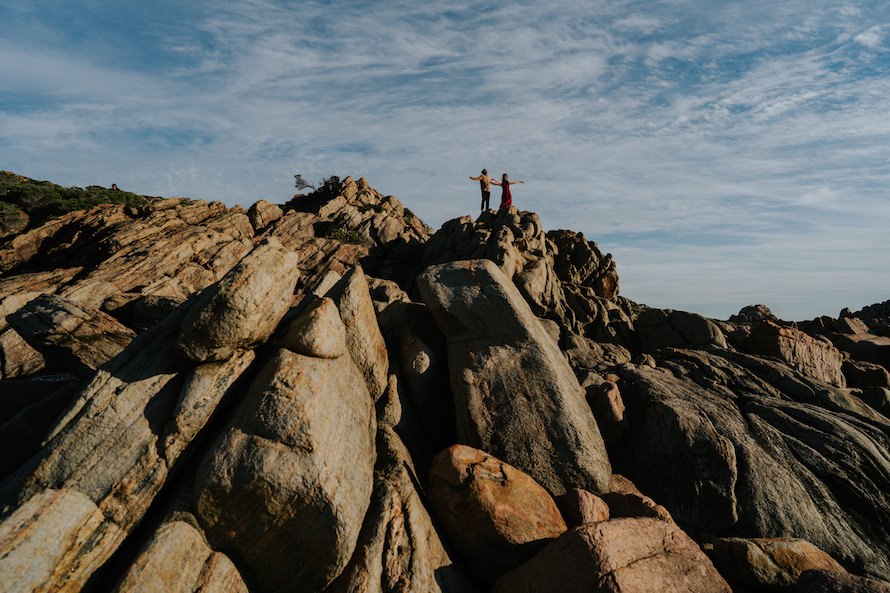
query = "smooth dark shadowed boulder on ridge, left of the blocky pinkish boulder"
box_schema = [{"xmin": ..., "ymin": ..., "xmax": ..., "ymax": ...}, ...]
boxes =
[{"xmin": 634, "ymin": 309, "xmax": 726, "ymax": 352}]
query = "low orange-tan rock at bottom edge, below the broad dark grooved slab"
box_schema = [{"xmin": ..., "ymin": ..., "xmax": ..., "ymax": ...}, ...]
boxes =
[{"xmin": 706, "ymin": 537, "xmax": 846, "ymax": 591}]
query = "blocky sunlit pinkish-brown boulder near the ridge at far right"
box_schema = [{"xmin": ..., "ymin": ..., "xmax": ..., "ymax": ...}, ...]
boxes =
[{"xmin": 745, "ymin": 321, "xmax": 846, "ymax": 387}]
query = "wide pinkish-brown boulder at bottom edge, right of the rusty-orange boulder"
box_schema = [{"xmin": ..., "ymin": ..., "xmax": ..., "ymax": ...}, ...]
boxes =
[{"xmin": 492, "ymin": 518, "xmax": 731, "ymax": 593}]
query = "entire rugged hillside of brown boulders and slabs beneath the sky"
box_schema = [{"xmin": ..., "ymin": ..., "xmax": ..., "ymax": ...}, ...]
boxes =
[{"xmin": 0, "ymin": 173, "xmax": 890, "ymax": 593}]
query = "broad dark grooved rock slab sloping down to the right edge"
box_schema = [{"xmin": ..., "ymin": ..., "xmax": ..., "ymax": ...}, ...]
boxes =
[{"xmin": 604, "ymin": 350, "xmax": 890, "ymax": 577}]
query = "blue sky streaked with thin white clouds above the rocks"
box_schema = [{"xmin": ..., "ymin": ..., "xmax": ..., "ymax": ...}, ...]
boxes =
[{"xmin": 0, "ymin": 0, "xmax": 890, "ymax": 319}]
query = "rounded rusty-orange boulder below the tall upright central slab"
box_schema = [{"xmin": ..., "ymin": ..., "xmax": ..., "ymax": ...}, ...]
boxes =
[{"xmin": 429, "ymin": 445, "xmax": 566, "ymax": 582}]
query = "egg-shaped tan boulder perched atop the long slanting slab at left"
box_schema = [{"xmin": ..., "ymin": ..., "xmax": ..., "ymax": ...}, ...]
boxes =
[{"xmin": 178, "ymin": 237, "xmax": 298, "ymax": 362}]
